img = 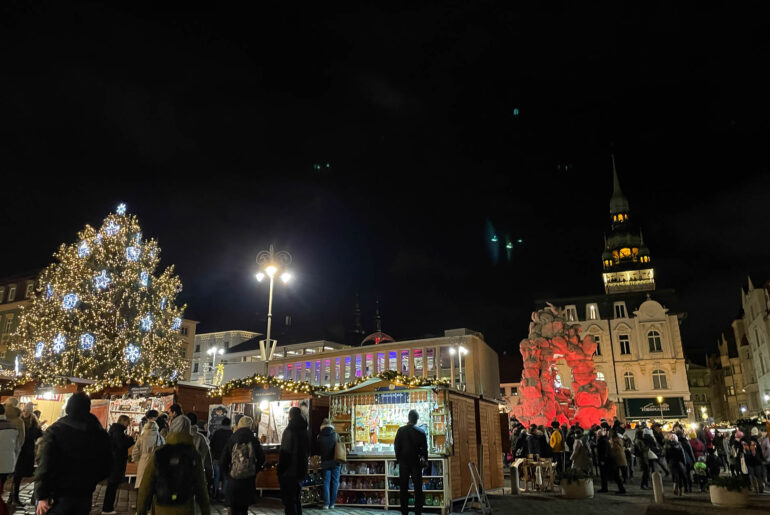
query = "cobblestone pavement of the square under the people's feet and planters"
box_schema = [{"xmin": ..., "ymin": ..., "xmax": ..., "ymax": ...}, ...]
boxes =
[{"xmin": 3, "ymin": 478, "xmax": 770, "ymax": 515}]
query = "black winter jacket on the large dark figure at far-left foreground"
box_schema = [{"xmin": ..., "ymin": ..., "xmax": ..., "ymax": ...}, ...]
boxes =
[{"xmin": 35, "ymin": 413, "xmax": 112, "ymax": 499}]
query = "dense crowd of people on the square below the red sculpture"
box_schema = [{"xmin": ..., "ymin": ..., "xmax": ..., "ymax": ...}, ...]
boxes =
[{"xmin": 505, "ymin": 417, "xmax": 770, "ymax": 495}]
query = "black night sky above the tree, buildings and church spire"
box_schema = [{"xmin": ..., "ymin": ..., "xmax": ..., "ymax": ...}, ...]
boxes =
[{"xmin": 0, "ymin": 1, "xmax": 770, "ymax": 370}]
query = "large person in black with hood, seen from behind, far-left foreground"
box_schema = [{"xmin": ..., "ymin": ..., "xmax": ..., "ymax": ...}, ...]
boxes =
[{"xmin": 35, "ymin": 392, "xmax": 112, "ymax": 515}]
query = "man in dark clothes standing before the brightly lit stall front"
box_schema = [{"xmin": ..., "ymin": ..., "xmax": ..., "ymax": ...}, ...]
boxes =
[{"xmin": 393, "ymin": 410, "xmax": 428, "ymax": 515}]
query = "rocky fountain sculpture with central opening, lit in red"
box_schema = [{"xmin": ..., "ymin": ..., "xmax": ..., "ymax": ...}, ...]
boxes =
[{"xmin": 513, "ymin": 304, "xmax": 615, "ymax": 428}]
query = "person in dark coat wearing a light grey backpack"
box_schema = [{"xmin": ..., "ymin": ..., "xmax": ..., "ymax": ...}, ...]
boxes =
[{"xmin": 219, "ymin": 416, "xmax": 265, "ymax": 515}]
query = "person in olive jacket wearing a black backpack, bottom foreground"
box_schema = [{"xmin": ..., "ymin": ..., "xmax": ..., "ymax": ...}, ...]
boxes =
[{"xmin": 136, "ymin": 415, "xmax": 211, "ymax": 515}]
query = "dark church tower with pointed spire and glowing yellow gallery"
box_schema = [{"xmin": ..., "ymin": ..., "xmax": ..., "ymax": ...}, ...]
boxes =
[{"xmin": 602, "ymin": 156, "xmax": 655, "ymax": 294}]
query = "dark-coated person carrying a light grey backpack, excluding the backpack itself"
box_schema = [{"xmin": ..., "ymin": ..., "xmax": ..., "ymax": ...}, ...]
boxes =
[{"xmin": 214, "ymin": 417, "xmax": 262, "ymax": 515}]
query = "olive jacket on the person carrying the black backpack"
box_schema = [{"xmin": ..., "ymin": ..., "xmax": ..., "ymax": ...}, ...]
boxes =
[{"xmin": 136, "ymin": 432, "xmax": 211, "ymax": 515}]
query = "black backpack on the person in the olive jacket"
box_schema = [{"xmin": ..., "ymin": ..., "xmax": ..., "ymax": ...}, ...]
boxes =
[{"xmin": 155, "ymin": 445, "xmax": 200, "ymax": 506}]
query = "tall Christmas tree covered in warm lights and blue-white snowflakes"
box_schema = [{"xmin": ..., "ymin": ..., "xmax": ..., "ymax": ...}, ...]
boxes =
[{"xmin": 12, "ymin": 204, "xmax": 186, "ymax": 386}]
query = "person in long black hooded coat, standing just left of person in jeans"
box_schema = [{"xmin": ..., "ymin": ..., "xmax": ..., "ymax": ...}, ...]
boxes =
[{"xmin": 278, "ymin": 406, "xmax": 310, "ymax": 515}]
